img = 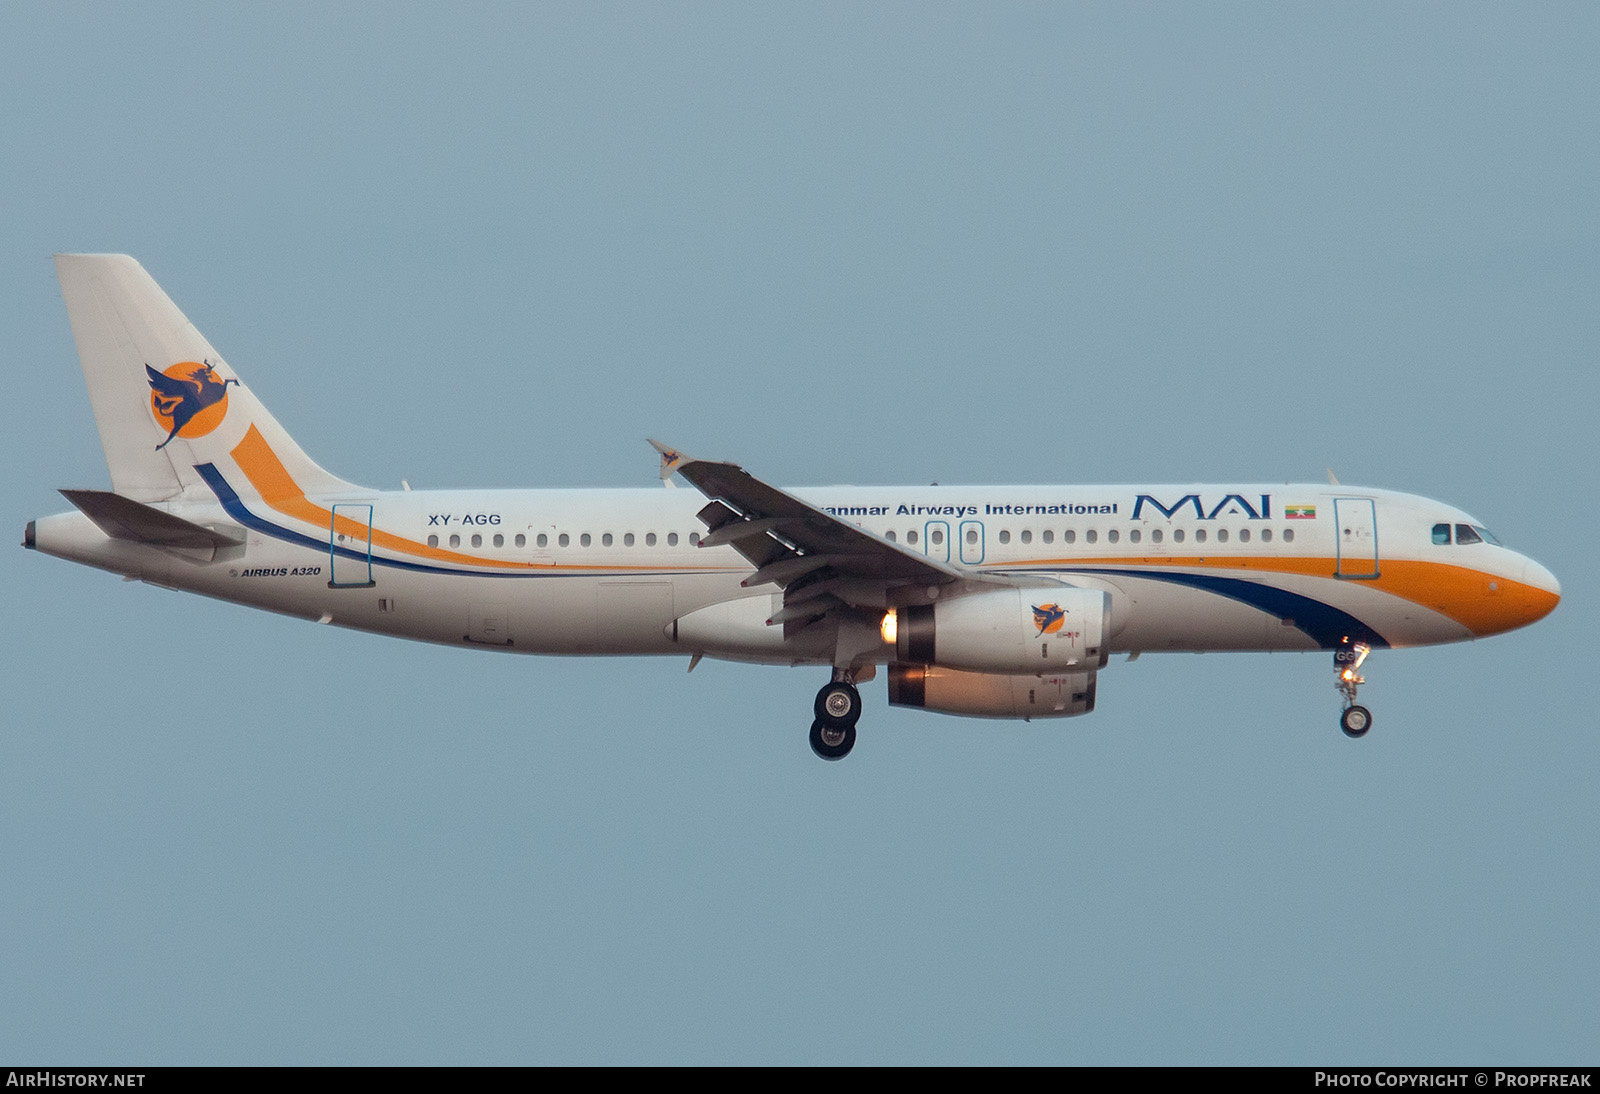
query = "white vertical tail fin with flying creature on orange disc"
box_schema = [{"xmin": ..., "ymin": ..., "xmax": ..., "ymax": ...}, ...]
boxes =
[{"xmin": 56, "ymin": 254, "xmax": 355, "ymax": 502}]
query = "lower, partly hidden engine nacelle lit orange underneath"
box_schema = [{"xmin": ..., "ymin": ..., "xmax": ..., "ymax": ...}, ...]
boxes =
[{"xmin": 888, "ymin": 664, "xmax": 1096, "ymax": 720}]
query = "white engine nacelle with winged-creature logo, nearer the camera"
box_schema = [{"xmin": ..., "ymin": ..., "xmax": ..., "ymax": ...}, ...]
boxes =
[{"xmin": 894, "ymin": 585, "xmax": 1110, "ymax": 677}]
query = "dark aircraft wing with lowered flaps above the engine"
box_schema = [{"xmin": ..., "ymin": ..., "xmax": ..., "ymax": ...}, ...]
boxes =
[{"xmin": 650, "ymin": 440, "xmax": 1010, "ymax": 625}]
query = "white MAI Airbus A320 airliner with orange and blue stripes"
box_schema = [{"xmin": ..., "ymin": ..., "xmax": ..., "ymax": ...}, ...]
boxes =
[{"xmin": 22, "ymin": 254, "xmax": 1560, "ymax": 760}]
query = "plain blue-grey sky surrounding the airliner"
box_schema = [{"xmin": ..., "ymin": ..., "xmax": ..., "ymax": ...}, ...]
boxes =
[{"xmin": 0, "ymin": 2, "xmax": 1600, "ymax": 1064}]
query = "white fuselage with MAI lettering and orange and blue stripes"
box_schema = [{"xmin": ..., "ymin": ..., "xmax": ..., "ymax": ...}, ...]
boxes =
[{"xmin": 34, "ymin": 480, "xmax": 1558, "ymax": 662}]
